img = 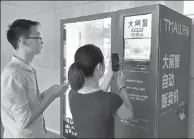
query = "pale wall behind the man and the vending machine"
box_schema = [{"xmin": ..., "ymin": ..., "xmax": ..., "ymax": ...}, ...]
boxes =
[{"xmin": 1, "ymin": 1, "xmax": 194, "ymax": 136}]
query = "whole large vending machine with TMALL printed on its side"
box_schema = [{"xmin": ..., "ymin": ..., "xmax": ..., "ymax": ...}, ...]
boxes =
[{"xmin": 61, "ymin": 4, "xmax": 192, "ymax": 138}]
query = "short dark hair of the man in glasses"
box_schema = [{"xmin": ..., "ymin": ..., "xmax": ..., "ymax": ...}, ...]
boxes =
[{"xmin": 7, "ymin": 19, "xmax": 40, "ymax": 49}]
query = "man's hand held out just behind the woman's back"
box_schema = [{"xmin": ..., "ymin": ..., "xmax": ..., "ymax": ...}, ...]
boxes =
[{"xmin": 47, "ymin": 84, "xmax": 69, "ymax": 98}]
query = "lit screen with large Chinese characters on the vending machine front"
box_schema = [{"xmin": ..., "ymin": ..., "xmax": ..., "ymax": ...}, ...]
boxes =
[{"xmin": 124, "ymin": 14, "xmax": 152, "ymax": 61}]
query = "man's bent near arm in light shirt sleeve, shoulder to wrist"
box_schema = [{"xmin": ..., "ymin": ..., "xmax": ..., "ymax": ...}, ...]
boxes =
[{"xmin": 1, "ymin": 73, "xmax": 55, "ymax": 128}]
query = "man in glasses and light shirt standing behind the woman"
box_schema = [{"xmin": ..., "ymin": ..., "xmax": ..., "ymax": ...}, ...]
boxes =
[{"xmin": 1, "ymin": 19, "xmax": 68, "ymax": 138}]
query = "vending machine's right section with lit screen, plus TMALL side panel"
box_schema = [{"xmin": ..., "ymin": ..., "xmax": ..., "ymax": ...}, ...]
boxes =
[{"xmin": 112, "ymin": 5, "xmax": 192, "ymax": 138}]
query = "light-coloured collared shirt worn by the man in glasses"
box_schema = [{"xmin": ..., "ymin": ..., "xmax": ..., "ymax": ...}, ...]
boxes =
[{"xmin": 1, "ymin": 56, "xmax": 46, "ymax": 138}]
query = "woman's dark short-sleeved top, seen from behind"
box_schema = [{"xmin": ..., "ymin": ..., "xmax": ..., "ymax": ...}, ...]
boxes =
[{"xmin": 69, "ymin": 90, "xmax": 122, "ymax": 138}]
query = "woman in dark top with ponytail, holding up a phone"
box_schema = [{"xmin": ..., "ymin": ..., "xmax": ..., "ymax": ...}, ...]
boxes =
[{"xmin": 68, "ymin": 44, "xmax": 132, "ymax": 138}]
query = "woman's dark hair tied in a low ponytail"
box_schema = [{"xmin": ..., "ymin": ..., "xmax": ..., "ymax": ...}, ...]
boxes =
[{"xmin": 68, "ymin": 44, "xmax": 104, "ymax": 91}]
